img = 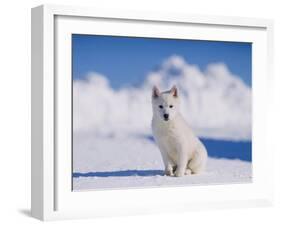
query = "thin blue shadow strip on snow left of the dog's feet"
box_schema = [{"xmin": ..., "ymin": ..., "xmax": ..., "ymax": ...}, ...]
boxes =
[{"xmin": 72, "ymin": 170, "xmax": 164, "ymax": 178}]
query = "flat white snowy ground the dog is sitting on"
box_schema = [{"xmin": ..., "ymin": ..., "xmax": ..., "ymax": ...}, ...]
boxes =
[{"xmin": 73, "ymin": 133, "xmax": 252, "ymax": 191}]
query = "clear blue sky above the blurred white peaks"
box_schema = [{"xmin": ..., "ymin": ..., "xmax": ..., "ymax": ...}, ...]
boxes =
[{"xmin": 72, "ymin": 34, "xmax": 252, "ymax": 89}]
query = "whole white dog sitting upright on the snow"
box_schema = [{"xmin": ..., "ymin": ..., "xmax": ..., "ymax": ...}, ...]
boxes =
[{"xmin": 152, "ymin": 86, "xmax": 208, "ymax": 177}]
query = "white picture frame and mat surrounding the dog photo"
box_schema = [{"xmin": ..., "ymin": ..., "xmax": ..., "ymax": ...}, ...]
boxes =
[{"xmin": 31, "ymin": 5, "xmax": 273, "ymax": 220}]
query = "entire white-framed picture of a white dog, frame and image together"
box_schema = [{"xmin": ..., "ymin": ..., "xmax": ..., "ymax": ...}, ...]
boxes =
[{"xmin": 31, "ymin": 5, "xmax": 273, "ymax": 220}]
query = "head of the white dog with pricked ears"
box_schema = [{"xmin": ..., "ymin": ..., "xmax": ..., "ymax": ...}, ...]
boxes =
[{"xmin": 152, "ymin": 86, "xmax": 179, "ymax": 122}]
